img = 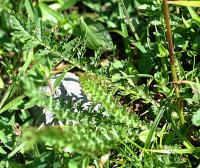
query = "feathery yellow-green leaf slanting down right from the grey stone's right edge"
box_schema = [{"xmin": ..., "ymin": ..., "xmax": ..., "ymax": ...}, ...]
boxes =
[{"xmin": 80, "ymin": 73, "xmax": 142, "ymax": 128}]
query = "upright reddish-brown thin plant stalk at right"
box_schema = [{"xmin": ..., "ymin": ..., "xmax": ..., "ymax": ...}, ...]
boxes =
[{"xmin": 163, "ymin": 0, "xmax": 185, "ymax": 125}]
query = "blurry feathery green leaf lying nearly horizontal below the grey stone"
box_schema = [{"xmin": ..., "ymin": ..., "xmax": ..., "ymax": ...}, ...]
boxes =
[{"xmin": 21, "ymin": 124, "xmax": 119, "ymax": 156}]
